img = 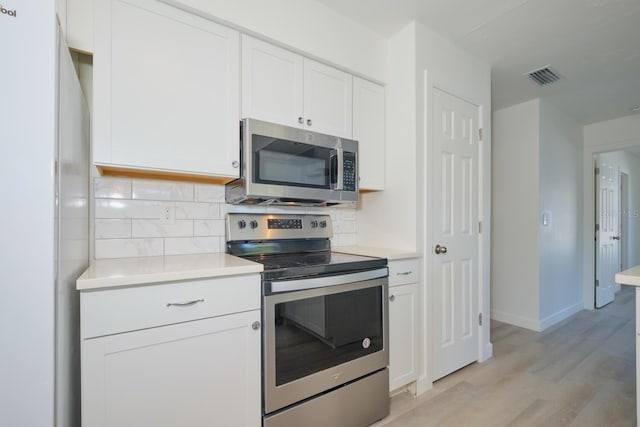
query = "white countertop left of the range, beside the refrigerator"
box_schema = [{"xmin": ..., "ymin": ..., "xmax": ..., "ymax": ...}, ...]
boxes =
[{"xmin": 76, "ymin": 253, "xmax": 263, "ymax": 290}]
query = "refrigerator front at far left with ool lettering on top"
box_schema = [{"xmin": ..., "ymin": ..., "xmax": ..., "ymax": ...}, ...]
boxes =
[{"xmin": 0, "ymin": 0, "xmax": 56, "ymax": 427}]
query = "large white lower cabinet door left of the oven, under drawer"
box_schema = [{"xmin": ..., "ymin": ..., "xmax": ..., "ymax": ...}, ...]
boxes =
[{"xmin": 82, "ymin": 310, "xmax": 261, "ymax": 427}]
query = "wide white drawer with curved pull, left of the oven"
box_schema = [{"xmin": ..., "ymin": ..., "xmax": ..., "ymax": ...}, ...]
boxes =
[{"xmin": 80, "ymin": 274, "xmax": 260, "ymax": 338}]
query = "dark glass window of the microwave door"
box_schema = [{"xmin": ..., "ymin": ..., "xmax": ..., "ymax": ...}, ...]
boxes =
[{"xmin": 252, "ymin": 134, "xmax": 331, "ymax": 189}]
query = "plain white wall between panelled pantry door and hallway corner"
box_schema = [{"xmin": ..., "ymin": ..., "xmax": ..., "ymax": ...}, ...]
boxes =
[{"xmin": 491, "ymin": 99, "xmax": 540, "ymax": 329}]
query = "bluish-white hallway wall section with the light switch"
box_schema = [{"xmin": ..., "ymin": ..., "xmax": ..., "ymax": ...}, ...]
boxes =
[{"xmin": 537, "ymin": 100, "xmax": 582, "ymax": 329}]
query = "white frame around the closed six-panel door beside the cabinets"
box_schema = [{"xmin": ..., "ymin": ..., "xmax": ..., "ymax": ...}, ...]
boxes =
[{"xmin": 416, "ymin": 68, "xmax": 493, "ymax": 395}]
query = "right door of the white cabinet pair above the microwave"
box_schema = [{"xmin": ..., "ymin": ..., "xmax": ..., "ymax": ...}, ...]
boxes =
[{"xmin": 304, "ymin": 58, "xmax": 353, "ymax": 138}]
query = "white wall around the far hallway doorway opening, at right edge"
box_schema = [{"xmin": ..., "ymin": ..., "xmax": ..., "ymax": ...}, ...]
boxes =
[{"xmin": 582, "ymin": 114, "xmax": 640, "ymax": 309}]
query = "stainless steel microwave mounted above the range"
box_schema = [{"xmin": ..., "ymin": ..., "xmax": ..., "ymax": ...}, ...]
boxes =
[{"xmin": 225, "ymin": 119, "xmax": 358, "ymax": 206}]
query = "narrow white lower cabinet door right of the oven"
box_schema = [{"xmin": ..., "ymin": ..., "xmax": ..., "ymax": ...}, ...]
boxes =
[{"xmin": 389, "ymin": 283, "xmax": 418, "ymax": 390}]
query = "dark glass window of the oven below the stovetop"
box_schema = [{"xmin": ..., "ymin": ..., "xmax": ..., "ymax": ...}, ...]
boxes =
[{"xmin": 275, "ymin": 286, "xmax": 384, "ymax": 386}]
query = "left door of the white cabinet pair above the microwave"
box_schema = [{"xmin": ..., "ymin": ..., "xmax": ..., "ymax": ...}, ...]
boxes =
[{"xmin": 242, "ymin": 35, "xmax": 304, "ymax": 127}]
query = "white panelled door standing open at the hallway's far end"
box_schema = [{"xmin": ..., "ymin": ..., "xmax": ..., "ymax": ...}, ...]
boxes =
[{"xmin": 595, "ymin": 158, "xmax": 620, "ymax": 308}]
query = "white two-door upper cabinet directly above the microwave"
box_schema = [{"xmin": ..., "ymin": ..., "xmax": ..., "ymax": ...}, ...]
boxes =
[{"xmin": 242, "ymin": 36, "xmax": 353, "ymax": 138}]
